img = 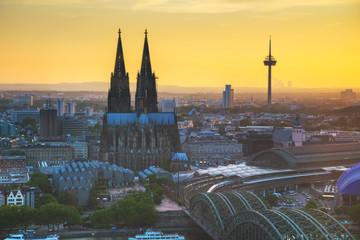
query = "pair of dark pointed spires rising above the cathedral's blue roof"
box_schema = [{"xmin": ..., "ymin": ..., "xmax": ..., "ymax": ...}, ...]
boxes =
[{"xmin": 108, "ymin": 29, "xmax": 158, "ymax": 114}]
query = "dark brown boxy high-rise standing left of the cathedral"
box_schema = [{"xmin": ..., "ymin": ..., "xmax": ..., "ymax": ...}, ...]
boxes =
[{"xmin": 40, "ymin": 107, "xmax": 60, "ymax": 138}]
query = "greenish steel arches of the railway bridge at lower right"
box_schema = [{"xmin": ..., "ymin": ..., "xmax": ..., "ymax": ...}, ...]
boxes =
[{"xmin": 188, "ymin": 192, "xmax": 355, "ymax": 240}]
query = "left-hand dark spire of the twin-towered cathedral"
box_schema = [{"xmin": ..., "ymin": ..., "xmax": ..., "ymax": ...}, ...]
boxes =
[{"xmin": 108, "ymin": 29, "xmax": 130, "ymax": 113}]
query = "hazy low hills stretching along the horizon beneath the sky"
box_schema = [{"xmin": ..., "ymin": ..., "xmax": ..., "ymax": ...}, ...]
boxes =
[{"xmin": 0, "ymin": 82, "xmax": 356, "ymax": 93}]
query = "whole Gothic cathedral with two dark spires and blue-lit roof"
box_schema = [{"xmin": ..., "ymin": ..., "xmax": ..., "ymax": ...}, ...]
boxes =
[{"xmin": 100, "ymin": 30, "xmax": 180, "ymax": 171}]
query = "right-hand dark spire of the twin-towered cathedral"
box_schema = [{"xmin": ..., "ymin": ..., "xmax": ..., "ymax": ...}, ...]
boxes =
[{"xmin": 135, "ymin": 29, "xmax": 158, "ymax": 114}]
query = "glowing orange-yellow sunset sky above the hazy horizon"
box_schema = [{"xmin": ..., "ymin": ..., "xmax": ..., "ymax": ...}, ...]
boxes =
[{"xmin": 0, "ymin": 0, "xmax": 360, "ymax": 88}]
